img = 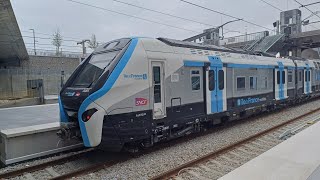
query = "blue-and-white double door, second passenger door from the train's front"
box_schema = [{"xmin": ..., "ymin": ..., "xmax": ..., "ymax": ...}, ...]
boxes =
[{"xmin": 274, "ymin": 62, "xmax": 287, "ymax": 100}]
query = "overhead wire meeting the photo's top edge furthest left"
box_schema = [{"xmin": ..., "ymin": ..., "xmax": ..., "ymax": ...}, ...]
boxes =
[{"xmin": 66, "ymin": 0, "xmax": 201, "ymax": 33}]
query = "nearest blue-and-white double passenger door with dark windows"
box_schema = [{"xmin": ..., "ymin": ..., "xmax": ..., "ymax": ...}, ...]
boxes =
[{"xmin": 206, "ymin": 57, "xmax": 226, "ymax": 114}]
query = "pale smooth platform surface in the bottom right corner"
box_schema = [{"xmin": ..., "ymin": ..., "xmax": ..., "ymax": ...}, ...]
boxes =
[{"xmin": 219, "ymin": 122, "xmax": 320, "ymax": 180}]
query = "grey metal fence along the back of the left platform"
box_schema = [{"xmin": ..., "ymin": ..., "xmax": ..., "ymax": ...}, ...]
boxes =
[{"xmin": 0, "ymin": 69, "xmax": 72, "ymax": 100}]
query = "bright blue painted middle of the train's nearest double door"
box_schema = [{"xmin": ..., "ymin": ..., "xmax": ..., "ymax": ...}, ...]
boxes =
[{"xmin": 209, "ymin": 56, "xmax": 223, "ymax": 113}]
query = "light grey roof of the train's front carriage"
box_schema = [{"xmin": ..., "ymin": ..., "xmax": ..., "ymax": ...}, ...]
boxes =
[{"xmin": 140, "ymin": 38, "xmax": 295, "ymax": 67}]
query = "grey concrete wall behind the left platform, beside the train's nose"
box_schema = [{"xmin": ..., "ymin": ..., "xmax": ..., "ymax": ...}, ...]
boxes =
[{"xmin": 0, "ymin": 56, "xmax": 79, "ymax": 99}]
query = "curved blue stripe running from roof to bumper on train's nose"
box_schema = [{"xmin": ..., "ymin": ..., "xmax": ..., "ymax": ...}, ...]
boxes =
[{"xmin": 78, "ymin": 38, "xmax": 138, "ymax": 147}]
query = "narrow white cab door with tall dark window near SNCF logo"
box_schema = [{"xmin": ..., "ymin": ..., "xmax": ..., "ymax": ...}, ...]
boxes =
[{"xmin": 151, "ymin": 61, "xmax": 166, "ymax": 119}]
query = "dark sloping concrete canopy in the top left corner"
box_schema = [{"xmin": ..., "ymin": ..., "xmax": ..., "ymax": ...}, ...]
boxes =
[{"xmin": 0, "ymin": 0, "xmax": 29, "ymax": 66}]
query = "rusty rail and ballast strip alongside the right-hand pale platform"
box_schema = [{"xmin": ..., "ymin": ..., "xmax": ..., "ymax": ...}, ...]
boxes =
[{"xmin": 151, "ymin": 108, "xmax": 320, "ymax": 180}]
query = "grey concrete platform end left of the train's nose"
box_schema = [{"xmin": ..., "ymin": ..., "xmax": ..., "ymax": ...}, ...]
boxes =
[{"xmin": 0, "ymin": 104, "xmax": 83, "ymax": 165}]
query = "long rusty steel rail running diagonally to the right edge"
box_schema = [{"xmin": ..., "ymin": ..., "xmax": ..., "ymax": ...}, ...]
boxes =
[{"xmin": 151, "ymin": 108, "xmax": 320, "ymax": 180}]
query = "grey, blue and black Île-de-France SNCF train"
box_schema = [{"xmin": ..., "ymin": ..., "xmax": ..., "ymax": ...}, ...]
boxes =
[{"xmin": 57, "ymin": 37, "xmax": 320, "ymax": 151}]
